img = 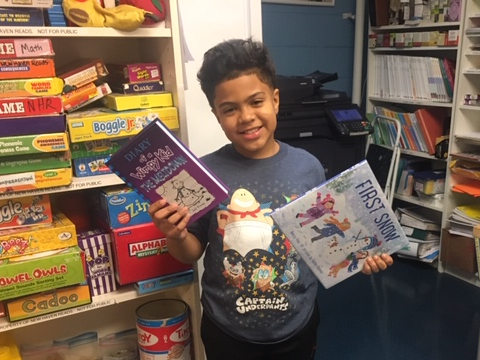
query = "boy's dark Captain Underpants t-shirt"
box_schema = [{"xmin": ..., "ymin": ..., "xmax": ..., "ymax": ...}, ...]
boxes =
[{"xmin": 189, "ymin": 142, "xmax": 325, "ymax": 343}]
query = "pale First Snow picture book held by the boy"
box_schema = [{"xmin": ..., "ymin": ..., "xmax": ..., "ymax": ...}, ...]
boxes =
[{"xmin": 272, "ymin": 160, "xmax": 408, "ymax": 289}]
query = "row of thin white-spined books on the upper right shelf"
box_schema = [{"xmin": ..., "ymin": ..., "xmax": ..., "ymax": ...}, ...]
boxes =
[{"xmin": 373, "ymin": 54, "xmax": 455, "ymax": 103}]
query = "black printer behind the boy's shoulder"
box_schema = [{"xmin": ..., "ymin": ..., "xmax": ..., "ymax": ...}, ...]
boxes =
[{"xmin": 275, "ymin": 71, "xmax": 373, "ymax": 179}]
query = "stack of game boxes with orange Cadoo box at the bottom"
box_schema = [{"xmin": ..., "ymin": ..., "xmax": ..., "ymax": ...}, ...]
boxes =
[{"xmin": 0, "ymin": 208, "xmax": 91, "ymax": 322}]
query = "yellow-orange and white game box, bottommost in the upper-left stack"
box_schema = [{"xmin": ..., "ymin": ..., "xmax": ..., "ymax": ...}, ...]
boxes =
[{"xmin": 0, "ymin": 167, "xmax": 73, "ymax": 194}]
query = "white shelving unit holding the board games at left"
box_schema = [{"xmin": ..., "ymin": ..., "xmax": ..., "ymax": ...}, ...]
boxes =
[{"xmin": 0, "ymin": 0, "xmax": 204, "ymax": 360}]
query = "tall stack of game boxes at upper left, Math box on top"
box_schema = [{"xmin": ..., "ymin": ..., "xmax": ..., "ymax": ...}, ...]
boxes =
[{"xmin": 0, "ymin": 38, "xmax": 72, "ymax": 193}]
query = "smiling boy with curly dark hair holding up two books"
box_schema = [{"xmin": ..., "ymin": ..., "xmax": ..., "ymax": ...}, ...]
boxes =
[{"xmin": 149, "ymin": 39, "xmax": 393, "ymax": 360}]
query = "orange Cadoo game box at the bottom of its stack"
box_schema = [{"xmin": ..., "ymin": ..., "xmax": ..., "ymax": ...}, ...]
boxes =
[{"xmin": 6, "ymin": 284, "xmax": 92, "ymax": 321}]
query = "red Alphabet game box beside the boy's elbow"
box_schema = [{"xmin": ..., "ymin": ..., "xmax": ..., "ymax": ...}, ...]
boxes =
[{"xmin": 110, "ymin": 223, "xmax": 192, "ymax": 285}]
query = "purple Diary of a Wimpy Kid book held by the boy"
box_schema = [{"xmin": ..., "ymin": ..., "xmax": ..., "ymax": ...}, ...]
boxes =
[{"xmin": 106, "ymin": 119, "xmax": 228, "ymax": 225}]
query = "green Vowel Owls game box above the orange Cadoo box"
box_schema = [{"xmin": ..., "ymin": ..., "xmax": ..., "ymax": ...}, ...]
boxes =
[{"xmin": 0, "ymin": 245, "xmax": 85, "ymax": 300}]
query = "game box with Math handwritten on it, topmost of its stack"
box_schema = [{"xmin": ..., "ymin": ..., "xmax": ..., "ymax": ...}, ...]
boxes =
[{"xmin": 0, "ymin": 38, "xmax": 55, "ymax": 59}]
